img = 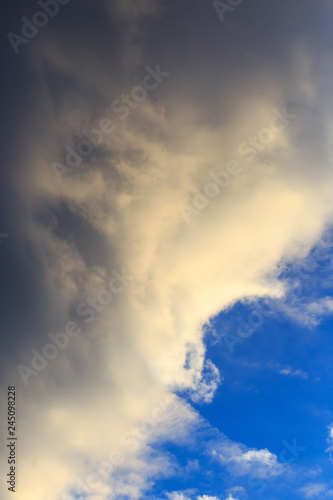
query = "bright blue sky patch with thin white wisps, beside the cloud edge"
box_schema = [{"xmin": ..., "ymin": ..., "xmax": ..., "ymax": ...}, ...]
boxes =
[{"xmin": 141, "ymin": 235, "xmax": 333, "ymax": 500}]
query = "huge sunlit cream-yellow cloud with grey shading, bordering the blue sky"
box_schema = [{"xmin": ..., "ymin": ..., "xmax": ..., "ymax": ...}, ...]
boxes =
[{"xmin": 1, "ymin": 1, "xmax": 333, "ymax": 500}]
